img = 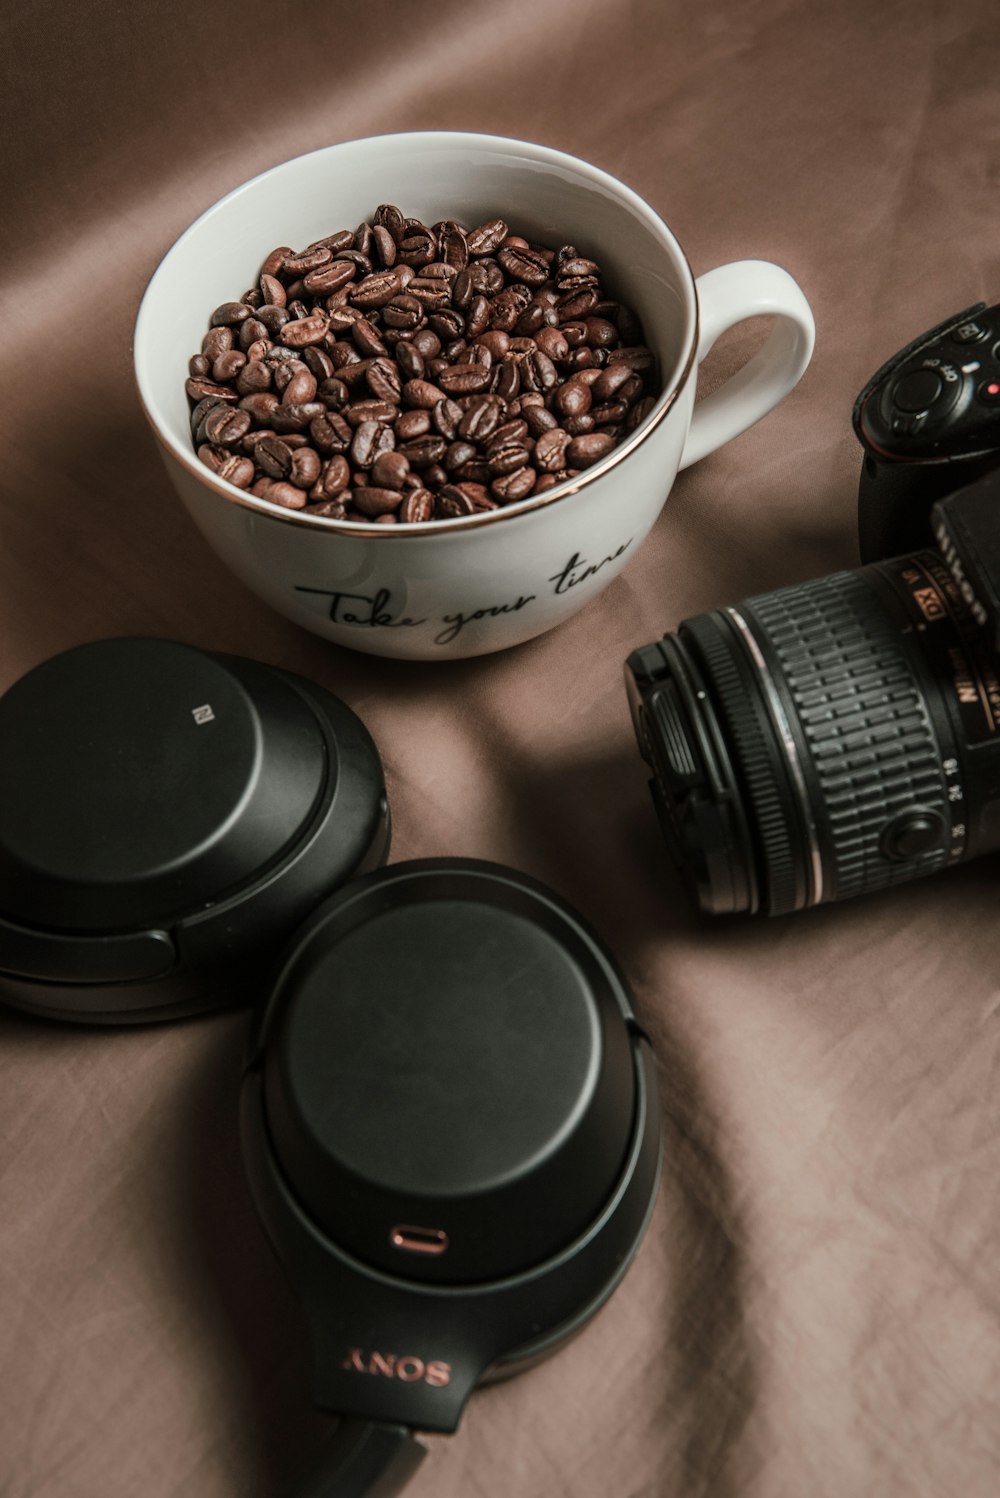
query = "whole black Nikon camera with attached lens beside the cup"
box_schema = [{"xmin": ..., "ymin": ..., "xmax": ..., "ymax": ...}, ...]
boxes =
[{"xmin": 626, "ymin": 304, "xmax": 1000, "ymax": 915}]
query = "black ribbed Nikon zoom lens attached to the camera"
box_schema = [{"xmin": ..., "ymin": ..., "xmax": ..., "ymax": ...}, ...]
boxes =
[{"xmin": 626, "ymin": 551, "xmax": 1000, "ymax": 915}]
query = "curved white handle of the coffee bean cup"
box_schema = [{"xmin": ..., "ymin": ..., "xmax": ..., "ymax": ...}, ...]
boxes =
[{"xmin": 680, "ymin": 261, "xmax": 816, "ymax": 467}]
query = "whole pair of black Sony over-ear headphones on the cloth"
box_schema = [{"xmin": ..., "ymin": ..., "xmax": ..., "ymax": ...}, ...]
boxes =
[{"xmin": 0, "ymin": 640, "xmax": 660, "ymax": 1498}]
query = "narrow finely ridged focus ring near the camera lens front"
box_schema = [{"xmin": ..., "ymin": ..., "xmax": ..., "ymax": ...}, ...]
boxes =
[{"xmin": 683, "ymin": 614, "xmax": 804, "ymax": 915}]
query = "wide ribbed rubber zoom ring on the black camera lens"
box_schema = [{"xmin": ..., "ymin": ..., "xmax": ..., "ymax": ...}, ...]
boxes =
[{"xmin": 740, "ymin": 572, "xmax": 951, "ymax": 896}]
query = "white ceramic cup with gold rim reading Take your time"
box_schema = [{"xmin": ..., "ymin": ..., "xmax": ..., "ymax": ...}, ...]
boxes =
[{"xmin": 135, "ymin": 132, "xmax": 814, "ymax": 659}]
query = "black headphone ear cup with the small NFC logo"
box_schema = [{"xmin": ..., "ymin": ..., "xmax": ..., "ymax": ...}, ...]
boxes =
[{"xmin": 0, "ymin": 640, "xmax": 388, "ymax": 1022}]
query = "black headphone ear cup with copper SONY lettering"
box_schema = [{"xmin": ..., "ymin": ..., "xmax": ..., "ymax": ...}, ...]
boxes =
[{"xmin": 243, "ymin": 860, "xmax": 660, "ymax": 1456}]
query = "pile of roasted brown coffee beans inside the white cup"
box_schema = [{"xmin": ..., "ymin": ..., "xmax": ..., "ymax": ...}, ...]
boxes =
[{"xmin": 186, "ymin": 204, "xmax": 659, "ymax": 524}]
